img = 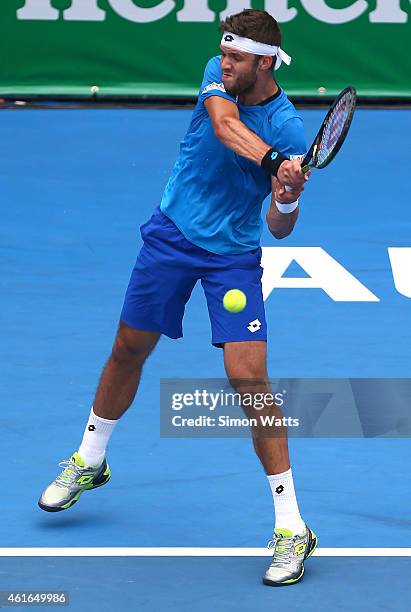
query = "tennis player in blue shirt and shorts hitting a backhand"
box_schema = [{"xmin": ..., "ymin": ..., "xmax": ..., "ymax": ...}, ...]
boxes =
[{"xmin": 39, "ymin": 10, "xmax": 317, "ymax": 585}]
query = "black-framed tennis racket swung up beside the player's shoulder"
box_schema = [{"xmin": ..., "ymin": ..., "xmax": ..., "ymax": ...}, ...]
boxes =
[{"xmin": 286, "ymin": 87, "xmax": 357, "ymax": 191}]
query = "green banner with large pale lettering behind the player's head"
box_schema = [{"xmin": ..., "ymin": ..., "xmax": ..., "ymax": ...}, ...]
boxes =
[{"xmin": 0, "ymin": 0, "xmax": 411, "ymax": 97}]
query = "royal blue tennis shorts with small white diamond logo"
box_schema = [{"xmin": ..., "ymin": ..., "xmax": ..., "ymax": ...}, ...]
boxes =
[{"xmin": 121, "ymin": 207, "xmax": 267, "ymax": 347}]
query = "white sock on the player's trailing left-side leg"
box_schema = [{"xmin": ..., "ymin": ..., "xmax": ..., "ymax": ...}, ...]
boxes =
[{"xmin": 78, "ymin": 408, "xmax": 118, "ymax": 467}]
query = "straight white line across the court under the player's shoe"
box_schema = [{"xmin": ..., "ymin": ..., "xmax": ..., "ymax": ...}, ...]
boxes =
[{"xmin": 0, "ymin": 547, "xmax": 411, "ymax": 557}]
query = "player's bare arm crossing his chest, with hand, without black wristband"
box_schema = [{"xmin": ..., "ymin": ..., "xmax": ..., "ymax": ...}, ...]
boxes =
[{"xmin": 204, "ymin": 96, "xmax": 306, "ymax": 185}]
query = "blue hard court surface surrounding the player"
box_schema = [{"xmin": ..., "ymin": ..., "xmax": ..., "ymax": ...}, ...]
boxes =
[{"xmin": 0, "ymin": 109, "xmax": 411, "ymax": 611}]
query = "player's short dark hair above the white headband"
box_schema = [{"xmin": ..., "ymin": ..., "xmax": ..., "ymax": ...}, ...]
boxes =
[{"xmin": 220, "ymin": 9, "xmax": 281, "ymax": 47}]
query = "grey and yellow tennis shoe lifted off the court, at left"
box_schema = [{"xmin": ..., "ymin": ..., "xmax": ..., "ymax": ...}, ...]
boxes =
[{"xmin": 38, "ymin": 453, "xmax": 111, "ymax": 512}]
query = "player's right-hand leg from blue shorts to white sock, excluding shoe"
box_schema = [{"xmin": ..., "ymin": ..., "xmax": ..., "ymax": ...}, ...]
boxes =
[{"xmin": 201, "ymin": 266, "xmax": 304, "ymax": 533}]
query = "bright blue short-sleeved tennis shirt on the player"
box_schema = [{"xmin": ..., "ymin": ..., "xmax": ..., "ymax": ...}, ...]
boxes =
[{"xmin": 160, "ymin": 56, "xmax": 306, "ymax": 255}]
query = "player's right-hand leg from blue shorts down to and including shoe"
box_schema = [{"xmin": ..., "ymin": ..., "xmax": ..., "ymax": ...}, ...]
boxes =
[{"xmin": 201, "ymin": 249, "xmax": 317, "ymax": 585}]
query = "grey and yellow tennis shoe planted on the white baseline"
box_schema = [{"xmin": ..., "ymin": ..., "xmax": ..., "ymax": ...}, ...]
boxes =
[{"xmin": 263, "ymin": 526, "xmax": 317, "ymax": 586}]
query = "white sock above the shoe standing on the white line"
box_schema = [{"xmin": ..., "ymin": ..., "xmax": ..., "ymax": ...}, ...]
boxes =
[{"xmin": 267, "ymin": 468, "xmax": 305, "ymax": 535}]
